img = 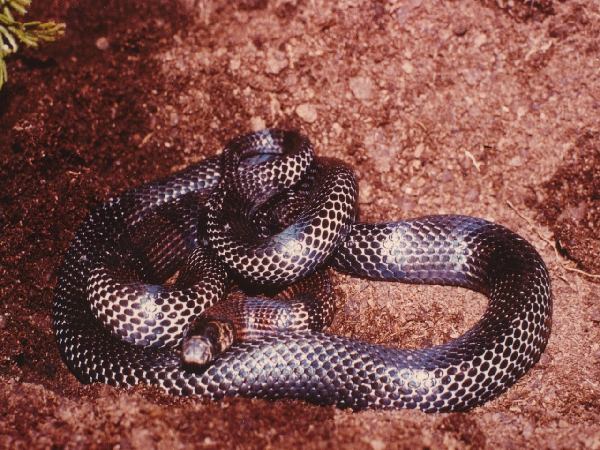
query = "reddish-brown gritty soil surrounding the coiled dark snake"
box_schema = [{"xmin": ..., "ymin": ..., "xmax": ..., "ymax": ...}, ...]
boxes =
[{"xmin": 0, "ymin": 0, "xmax": 600, "ymax": 450}]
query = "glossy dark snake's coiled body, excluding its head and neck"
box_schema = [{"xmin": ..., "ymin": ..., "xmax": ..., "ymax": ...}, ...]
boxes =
[{"xmin": 53, "ymin": 129, "xmax": 553, "ymax": 413}]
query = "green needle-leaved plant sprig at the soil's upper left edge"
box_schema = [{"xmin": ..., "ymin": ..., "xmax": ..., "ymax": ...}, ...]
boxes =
[{"xmin": 0, "ymin": 0, "xmax": 65, "ymax": 89}]
